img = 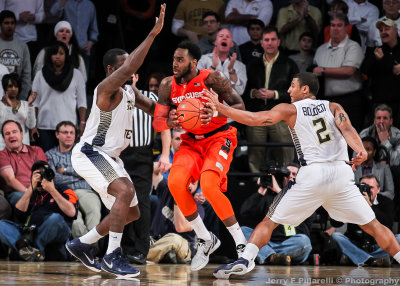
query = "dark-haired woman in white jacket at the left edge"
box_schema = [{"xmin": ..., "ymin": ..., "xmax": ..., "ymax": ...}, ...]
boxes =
[{"xmin": 0, "ymin": 73, "xmax": 36, "ymax": 150}]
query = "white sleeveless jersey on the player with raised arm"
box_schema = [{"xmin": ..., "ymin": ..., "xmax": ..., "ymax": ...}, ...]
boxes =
[{"xmin": 81, "ymin": 87, "xmax": 135, "ymax": 158}]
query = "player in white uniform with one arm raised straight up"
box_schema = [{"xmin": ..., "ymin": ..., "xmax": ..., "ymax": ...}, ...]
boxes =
[{"xmin": 66, "ymin": 4, "xmax": 165, "ymax": 277}]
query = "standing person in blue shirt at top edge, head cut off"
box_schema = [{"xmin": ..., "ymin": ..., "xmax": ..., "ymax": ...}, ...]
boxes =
[{"xmin": 50, "ymin": 0, "xmax": 99, "ymax": 77}]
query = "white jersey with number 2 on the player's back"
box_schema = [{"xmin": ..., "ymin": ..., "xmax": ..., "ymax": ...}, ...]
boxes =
[{"xmin": 289, "ymin": 98, "xmax": 349, "ymax": 166}]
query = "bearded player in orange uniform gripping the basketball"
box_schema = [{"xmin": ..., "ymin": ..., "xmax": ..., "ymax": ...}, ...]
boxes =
[{"xmin": 153, "ymin": 42, "xmax": 246, "ymax": 271}]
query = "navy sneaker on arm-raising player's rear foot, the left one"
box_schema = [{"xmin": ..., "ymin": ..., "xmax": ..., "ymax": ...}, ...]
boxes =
[{"xmin": 65, "ymin": 238, "xmax": 101, "ymax": 272}]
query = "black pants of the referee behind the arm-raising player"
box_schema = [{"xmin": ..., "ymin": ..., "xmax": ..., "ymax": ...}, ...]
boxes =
[{"xmin": 120, "ymin": 146, "xmax": 153, "ymax": 257}]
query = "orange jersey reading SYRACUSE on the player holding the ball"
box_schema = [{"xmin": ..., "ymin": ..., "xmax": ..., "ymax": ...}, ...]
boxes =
[{"xmin": 171, "ymin": 69, "xmax": 227, "ymax": 134}]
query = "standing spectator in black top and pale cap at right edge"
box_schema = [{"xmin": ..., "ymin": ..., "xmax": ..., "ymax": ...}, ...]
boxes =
[{"xmin": 362, "ymin": 19, "xmax": 400, "ymax": 127}]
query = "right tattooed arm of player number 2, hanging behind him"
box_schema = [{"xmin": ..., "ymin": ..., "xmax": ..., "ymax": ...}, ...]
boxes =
[{"xmin": 329, "ymin": 102, "xmax": 367, "ymax": 170}]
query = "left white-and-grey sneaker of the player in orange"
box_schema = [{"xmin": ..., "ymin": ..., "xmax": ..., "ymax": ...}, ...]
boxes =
[{"xmin": 190, "ymin": 232, "xmax": 221, "ymax": 271}]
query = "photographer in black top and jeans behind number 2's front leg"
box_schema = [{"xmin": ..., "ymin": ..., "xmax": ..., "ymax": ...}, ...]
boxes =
[{"xmin": 240, "ymin": 164, "xmax": 314, "ymax": 265}]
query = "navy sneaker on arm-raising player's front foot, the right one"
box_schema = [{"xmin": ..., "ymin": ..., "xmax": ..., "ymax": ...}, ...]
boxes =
[{"xmin": 101, "ymin": 247, "xmax": 140, "ymax": 278}]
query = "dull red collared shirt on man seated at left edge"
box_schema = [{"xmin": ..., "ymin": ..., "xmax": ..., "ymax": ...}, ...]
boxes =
[{"xmin": 0, "ymin": 145, "xmax": 47, "ymax": 188}]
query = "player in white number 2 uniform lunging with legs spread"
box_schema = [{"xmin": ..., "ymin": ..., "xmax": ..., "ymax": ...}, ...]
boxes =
[{"xmin": 204, "ymin": 73, "xmax": 400, "ymax": 279}]
